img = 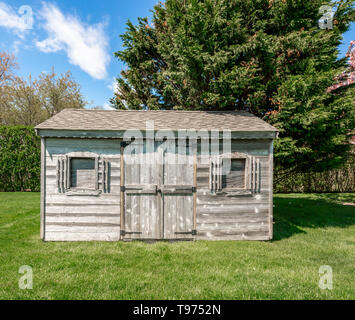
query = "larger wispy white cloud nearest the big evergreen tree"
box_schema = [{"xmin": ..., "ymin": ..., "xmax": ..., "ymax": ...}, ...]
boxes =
[{"xmin": 36, "ymin": 4, "xmax": 110, "ymax": 79}]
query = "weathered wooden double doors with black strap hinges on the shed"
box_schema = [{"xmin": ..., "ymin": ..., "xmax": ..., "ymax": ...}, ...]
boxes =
[{"xmin": 121, "ymin": 141, "xmax": 196, "ymax": 239}]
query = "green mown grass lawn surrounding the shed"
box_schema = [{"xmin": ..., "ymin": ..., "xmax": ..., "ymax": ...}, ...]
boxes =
[{"xmin": 0, "ymin": 193, "xmax": 355, "ymax": 299}]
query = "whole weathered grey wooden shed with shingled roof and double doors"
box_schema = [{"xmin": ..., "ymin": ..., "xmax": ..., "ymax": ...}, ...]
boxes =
[{"xmin": 36, "ymin": 109, "xmax": 277, "ymax": 241}]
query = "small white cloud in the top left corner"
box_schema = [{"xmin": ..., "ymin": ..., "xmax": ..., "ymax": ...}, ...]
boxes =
[{"xmin": 0, "ymin": 2, "xmax": 32, "ymax": 38}]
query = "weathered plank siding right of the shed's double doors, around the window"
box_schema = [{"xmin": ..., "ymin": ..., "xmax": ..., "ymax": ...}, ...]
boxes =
[{"xmin": 197, "ymin": 140, "xmax": 272, "ymax": 240}]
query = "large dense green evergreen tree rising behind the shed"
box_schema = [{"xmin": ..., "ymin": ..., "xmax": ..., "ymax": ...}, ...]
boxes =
[{"xmin": 111, "ymin": 0, "xmax": 354, "ymax": 174}]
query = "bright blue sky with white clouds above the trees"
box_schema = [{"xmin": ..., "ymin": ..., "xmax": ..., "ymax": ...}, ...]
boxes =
[{"xmin": 0, "ymin": 0, "xmax": 355, "ymax": 107}]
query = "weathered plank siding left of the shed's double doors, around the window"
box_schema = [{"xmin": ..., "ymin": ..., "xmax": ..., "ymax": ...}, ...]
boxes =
[{"xmin": 45, "ymin": 138, "xmax": 120, "ymax": 241}]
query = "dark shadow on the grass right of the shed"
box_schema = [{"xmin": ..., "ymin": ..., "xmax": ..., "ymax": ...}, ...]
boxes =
[{"xmin": 273, "ymin": 194, "xmax": 355, "ymax": 241}]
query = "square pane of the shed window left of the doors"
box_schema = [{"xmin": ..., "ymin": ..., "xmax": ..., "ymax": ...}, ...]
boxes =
[{"xmin": 70, "ymin": 158, "xmax": 96, "ymax": 189}]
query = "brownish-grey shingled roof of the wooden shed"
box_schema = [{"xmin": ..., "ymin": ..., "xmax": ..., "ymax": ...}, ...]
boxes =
[{"xmin": 36, "ymin": 109, "xmax": 278, "ymax": 132}]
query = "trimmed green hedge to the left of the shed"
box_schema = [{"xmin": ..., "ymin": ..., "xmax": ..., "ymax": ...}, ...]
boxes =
[{"xmin": 0, "ymin": 126, "xmax": 41, "ymax": 192}]
